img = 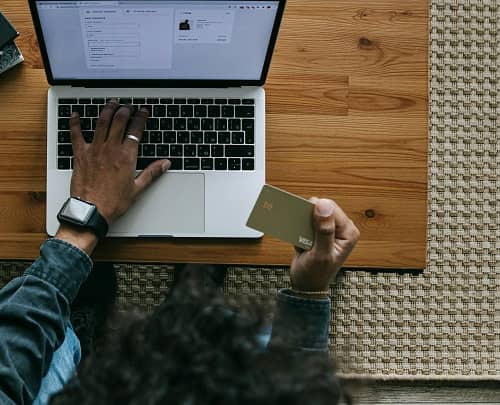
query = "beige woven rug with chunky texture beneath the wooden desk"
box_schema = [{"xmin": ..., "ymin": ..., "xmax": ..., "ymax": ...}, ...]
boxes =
[{"xmin": 0, "ymin": 0, "xmax": 500, "ymax": 379}]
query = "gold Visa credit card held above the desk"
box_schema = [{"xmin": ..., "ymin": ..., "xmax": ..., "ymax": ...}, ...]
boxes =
[{"xmin": 247, "ymin": 184, "xmax": 314, "ymax": 250}]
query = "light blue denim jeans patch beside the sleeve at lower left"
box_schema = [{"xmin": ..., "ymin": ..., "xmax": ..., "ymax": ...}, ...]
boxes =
[{"xmin": 33, "ymin": 324, "xmax": 82, "ymax": 405}]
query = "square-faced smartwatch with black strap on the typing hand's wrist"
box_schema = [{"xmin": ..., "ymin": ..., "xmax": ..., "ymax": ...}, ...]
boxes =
[{"xmin": 57, "ymin": 197, "xmax": 108, "ymax": 239}]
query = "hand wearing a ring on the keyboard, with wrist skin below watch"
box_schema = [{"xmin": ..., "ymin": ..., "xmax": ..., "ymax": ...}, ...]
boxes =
[{"xmin": 55, "ymin": 100, "xmax": 170, "ymax": 254}]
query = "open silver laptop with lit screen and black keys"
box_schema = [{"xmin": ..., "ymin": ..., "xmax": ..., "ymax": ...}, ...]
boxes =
[{"xmin": 29, "ymin": 0, "xmax": 285, "ymax": 238}]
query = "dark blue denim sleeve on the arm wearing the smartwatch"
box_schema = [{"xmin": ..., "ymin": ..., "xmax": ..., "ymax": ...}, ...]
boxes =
[{"xmin": 0, "ymin": 239, "xmax": 92, "ymax": 405}]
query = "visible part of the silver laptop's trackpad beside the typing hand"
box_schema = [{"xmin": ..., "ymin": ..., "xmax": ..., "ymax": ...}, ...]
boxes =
[{"xmin": 110, "ymin": 173, "xmax": 205, "ymax": 236}]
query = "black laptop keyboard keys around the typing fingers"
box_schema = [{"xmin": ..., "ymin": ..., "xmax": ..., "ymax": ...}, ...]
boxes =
[{"xmin": 57, "ymin": 97, "xmax": 255, "ymax": 171}]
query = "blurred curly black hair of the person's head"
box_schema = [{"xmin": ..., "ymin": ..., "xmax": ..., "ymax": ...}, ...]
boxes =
[{"xmin": 51, "ymin": 266, "xmax": 343, "ymax": 405}]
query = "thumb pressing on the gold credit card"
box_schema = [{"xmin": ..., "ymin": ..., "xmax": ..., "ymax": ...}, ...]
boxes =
[{"xmin": 313, "ymin": 198, "xmax": 335, "ymax": 253}]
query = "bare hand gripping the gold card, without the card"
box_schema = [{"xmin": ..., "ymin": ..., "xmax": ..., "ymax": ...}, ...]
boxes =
[{"xmin": 290, "ymin": 197, "xmax": 359, "ymax": 292}]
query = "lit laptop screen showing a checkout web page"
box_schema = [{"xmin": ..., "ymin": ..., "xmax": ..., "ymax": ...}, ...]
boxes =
[{"xmin": 37, "ymin": 0, "xmax": 278, "ymax": 80}]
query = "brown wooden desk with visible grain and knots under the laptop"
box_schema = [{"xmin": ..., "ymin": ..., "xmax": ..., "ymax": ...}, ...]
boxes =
[{"xmin": 0, "ymin": 0, "xmax": 428, "ymax": 268}]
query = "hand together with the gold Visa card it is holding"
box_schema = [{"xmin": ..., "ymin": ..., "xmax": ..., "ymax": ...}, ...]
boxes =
[{"xmin": 247, "ymin": 185, "xmax": 359, "ymax": 298}]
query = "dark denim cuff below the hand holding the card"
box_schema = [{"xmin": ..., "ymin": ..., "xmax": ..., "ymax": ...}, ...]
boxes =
[{"xmin": 269, "ymin": 289, "xmax": 330, "ymax": 352}]
